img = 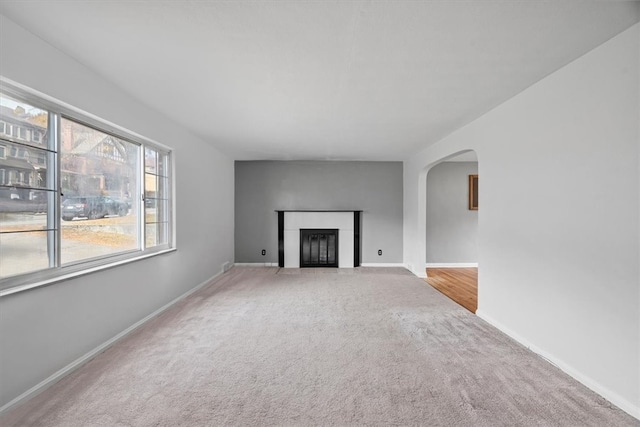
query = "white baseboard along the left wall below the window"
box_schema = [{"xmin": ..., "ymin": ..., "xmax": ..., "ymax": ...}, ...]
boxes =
[{"xmin": 0, "ymin": 271, "xmax": 229, "ymax": 415}]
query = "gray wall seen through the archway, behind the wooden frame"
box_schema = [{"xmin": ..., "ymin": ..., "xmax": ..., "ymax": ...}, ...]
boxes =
[{"xmin": 427, "ymin": 162, "xmax": 478, "ymax": 263}]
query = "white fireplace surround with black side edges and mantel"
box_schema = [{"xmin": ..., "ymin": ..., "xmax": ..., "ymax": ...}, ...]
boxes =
[{"xmin": 276, "ymin": 210, "xmax": 362, "ymax": 268}]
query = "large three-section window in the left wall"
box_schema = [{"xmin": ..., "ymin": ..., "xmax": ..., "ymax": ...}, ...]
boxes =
[{"xmin": 0, "ymin": 85, "xmax": 172, "ymax": 290}]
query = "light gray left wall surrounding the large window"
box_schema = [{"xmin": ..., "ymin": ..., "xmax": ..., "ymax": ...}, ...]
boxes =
[{"xmin": 0, "ymin": 16, "xmax": 234, "ymax": 407}]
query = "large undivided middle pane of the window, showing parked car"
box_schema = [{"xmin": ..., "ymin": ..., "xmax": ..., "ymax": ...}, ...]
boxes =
[{"xmin": 60, "ymin": 119, "xmax": 140, "ymax": 264}]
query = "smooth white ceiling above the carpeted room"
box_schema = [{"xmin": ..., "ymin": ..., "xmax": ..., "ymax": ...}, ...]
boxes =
[{"xmin": 0, "ymin": 0, "xmax": 640, "ymax": 160}]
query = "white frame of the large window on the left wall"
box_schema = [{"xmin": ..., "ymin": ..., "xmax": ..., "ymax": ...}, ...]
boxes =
[{"xmin": 0, "ymin": 78, "xmax": 176, "ymax": 297}]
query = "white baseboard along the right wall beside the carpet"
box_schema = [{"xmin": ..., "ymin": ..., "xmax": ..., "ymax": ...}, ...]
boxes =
[{"xmin": 476, "ymin": 309, "xmax": 640, "ymax": 420}]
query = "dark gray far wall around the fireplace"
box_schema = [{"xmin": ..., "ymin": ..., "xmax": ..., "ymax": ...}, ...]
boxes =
[{"xmin": 235, "ymin": 161, "xmax": 403, "ymax": 263}]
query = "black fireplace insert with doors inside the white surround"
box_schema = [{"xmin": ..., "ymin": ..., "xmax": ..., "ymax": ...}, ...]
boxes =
[{"xmin": 300, "ymin": 228, "xmax": 338, "ymax": 268}]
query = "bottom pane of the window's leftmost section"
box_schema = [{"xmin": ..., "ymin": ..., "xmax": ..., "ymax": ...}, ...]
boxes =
[{"xmin": 0, "ymin": 231, "xmax": 49, "ymax": 277}]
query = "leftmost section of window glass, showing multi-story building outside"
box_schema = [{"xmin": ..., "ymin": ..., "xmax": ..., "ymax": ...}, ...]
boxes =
[{"xmin": 0, "ymin": 96, "xmax": 56, "ymax": 277}]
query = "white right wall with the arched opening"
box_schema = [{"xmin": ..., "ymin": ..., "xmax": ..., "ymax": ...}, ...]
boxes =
[{"xmin": 404, "ymin": 24, "xmax": 640, "ymax": 417}]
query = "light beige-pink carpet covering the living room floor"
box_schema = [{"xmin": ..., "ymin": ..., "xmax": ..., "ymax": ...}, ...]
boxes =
[{"xmin": 0, "ymin": 267, "xmax": 638, "ymax": 426}]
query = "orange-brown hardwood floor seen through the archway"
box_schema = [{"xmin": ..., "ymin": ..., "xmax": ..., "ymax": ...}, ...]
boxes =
[{"xmin": 425, "ymin": 267, "xmax": 478, "ymax": 313}]
